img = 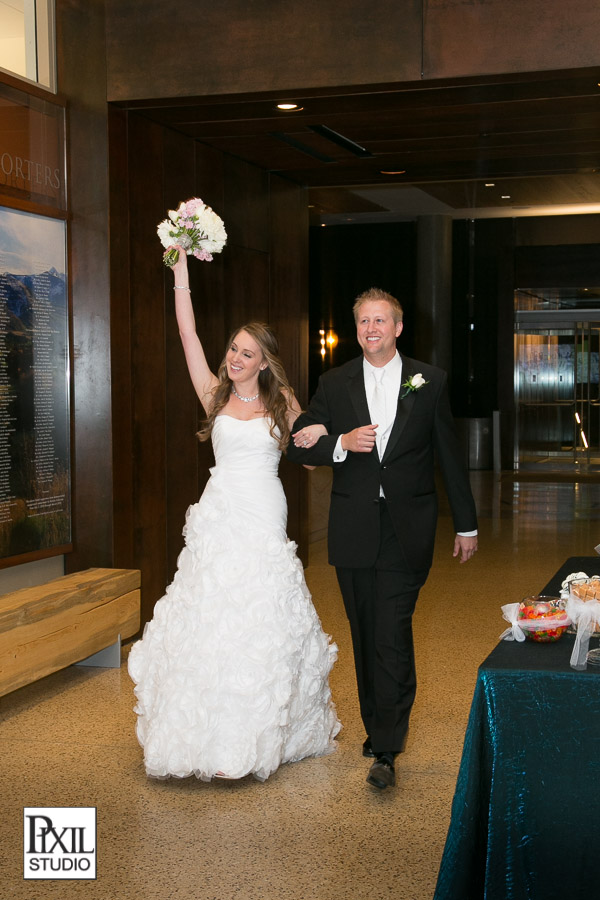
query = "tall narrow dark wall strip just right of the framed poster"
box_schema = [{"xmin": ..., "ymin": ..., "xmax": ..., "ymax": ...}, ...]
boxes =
[{"xmin": 57, "ymin": 0, "xmax": 113, "ymax": 572}]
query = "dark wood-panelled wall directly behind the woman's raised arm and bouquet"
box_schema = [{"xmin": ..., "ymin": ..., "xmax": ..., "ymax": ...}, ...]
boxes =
[{"xmin": 110, "ymin": 112, "xmax": 308, "ymax": 621}]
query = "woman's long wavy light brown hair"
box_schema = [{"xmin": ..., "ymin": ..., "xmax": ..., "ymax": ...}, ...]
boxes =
[{"xmin": 198, "ymin": 322, "xmax": 294, "ymax": 450}]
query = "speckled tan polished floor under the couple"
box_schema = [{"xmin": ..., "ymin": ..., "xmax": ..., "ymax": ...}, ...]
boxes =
[{"xmin": 0, "ymin": 472, "xmax": 600, "ymax": 900}]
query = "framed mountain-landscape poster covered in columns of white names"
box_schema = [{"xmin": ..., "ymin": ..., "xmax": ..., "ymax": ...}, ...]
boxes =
[{"xmin": 0, "ymin": 207, "xmax": 71, "ymax": 566}]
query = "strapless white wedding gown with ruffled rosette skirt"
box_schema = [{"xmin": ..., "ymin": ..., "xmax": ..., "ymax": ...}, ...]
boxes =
[{"xmin": 128, "ymin": 415, "xmax": 341, "ymax": 781}]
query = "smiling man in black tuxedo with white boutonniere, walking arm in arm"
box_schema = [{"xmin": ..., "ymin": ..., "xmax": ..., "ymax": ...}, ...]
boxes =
[{"xmin": 288, "ymin": 288, "xmax": 477, "ymax": 789}]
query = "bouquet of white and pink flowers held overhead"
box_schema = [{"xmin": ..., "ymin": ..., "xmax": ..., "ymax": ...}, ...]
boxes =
[{"xmin": 156, "ymin": 197, "xmax": 227, "ymax": 267}]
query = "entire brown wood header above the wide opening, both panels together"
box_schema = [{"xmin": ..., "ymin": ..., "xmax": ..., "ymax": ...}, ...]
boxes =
[{"xmin": 106, "ymin": 0, "xmax": 600, "ymax": 100}]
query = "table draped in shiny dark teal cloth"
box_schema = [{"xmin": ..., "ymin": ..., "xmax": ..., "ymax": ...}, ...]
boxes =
[{"xmin": 434, "ymin": 556, "xmax": 600, "ymax": 900}]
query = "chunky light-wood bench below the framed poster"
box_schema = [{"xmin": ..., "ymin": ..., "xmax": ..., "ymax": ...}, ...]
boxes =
[{"xmin": 0, "ymin": 569, "xmax": 141, "ymax": 696}]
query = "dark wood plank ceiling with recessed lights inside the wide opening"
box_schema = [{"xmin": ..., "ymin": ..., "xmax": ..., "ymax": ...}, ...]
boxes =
[{"xmin": 127, "ymin": 68, "xmax": 600, "ymax": 221}]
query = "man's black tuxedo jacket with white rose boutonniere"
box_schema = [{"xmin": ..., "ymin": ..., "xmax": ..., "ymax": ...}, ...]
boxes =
[{"xmin": 287, "ymin": 356, "xmax": 477, "ymax": 571}]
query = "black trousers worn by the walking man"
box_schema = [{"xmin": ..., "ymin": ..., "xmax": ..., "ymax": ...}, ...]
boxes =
[{"xmin": 336, "ymin": 500, "xmax": 428, "ymax": 753}]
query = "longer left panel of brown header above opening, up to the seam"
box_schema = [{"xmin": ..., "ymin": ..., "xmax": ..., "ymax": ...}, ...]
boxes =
[{"xmin": 106, "ymin": 0, "xmax": 421, "ymax": 100}]
